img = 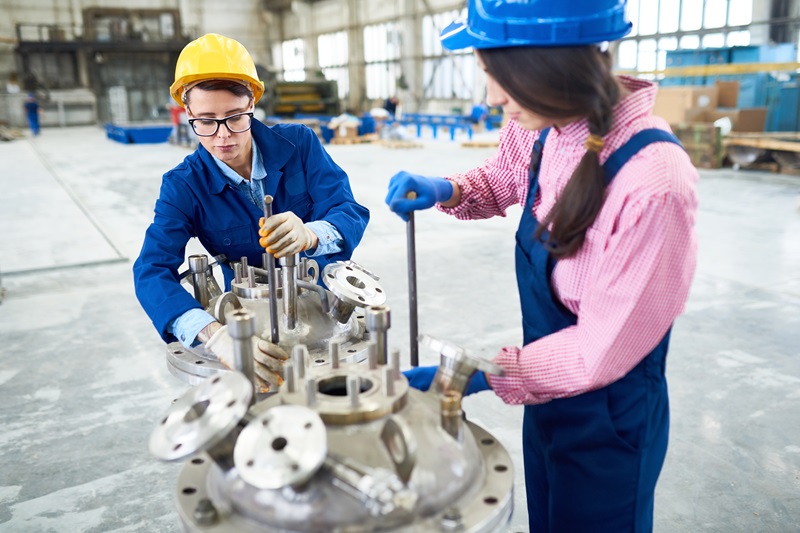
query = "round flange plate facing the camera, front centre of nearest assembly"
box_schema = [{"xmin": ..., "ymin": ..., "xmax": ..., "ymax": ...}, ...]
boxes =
[{"xmin": 233, "ymin": 405, "xmax": 328, "ymax": 489}]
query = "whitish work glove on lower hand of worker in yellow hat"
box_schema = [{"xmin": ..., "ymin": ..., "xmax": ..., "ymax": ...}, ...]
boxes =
[{"xmin": 205, "ymin": 326, "xmax": 289, "ymax": 392}]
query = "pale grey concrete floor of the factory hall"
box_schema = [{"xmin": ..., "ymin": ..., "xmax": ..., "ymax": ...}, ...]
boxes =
[{"xmin": 0, "ymin": 128, "xmax": 800, "ymax": 533}]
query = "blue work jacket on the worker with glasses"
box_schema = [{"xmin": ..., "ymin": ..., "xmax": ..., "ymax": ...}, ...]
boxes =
[{"xmin": 133, "ymin": 120, "xmax": 369, "ymax": 342}]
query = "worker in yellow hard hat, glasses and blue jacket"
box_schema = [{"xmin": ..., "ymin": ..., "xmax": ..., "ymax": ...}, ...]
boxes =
[{"xmin": 133, "ymin": 34, "xmax": 369, "ymax": 384}]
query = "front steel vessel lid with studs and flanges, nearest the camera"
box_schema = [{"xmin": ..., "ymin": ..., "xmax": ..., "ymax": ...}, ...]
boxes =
[{"xmin": 155, "ymin": 336, "xmax": 513, "ymax": 533}]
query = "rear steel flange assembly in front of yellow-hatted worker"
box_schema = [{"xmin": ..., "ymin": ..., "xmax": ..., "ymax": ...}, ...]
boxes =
[{"xmin": 166, "ymin": 254, "xmax": 388, "ymax": 392}]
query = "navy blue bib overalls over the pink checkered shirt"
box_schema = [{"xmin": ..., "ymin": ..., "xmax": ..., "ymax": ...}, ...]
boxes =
[{"xmin": 516, "ymin": 129, "xmax": 679, "ymax": 533}]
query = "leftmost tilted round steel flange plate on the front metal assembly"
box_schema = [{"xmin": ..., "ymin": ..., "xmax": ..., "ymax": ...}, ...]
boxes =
[{"xmin": 150, "ymin": 372, "xmax": 253, "ymax": 461}]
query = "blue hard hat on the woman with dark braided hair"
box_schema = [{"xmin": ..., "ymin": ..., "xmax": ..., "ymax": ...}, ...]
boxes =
[{"xmin": 440, "ymin": 0, "xmax": 632, "ymax": 50}]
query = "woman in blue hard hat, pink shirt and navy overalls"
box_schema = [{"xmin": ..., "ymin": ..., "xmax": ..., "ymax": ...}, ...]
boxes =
[{"xmin": 386, "ymin": 0, "xmax": 698, "ymax": 532}]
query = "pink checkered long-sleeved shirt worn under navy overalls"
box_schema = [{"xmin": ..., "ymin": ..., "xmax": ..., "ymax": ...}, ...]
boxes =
[{"xmin": 440, "ymin": 77, "xmax": 698, "ymax": 404}]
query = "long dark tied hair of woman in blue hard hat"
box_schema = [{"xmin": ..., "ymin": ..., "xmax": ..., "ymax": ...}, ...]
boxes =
[{"xmin": 478, "ymin": 46, "xmax": 620, "ymax": 258}]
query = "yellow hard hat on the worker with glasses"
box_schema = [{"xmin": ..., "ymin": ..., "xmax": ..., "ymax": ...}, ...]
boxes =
[{"xmin": 169, "ymin": 33, "xmax": 264, "ymax": 106}]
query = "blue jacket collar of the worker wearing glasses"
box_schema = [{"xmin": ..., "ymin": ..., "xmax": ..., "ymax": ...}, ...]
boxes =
[{"xmin": 197, "ymin": 119, "xmax": 297, "ymax": 196}]
